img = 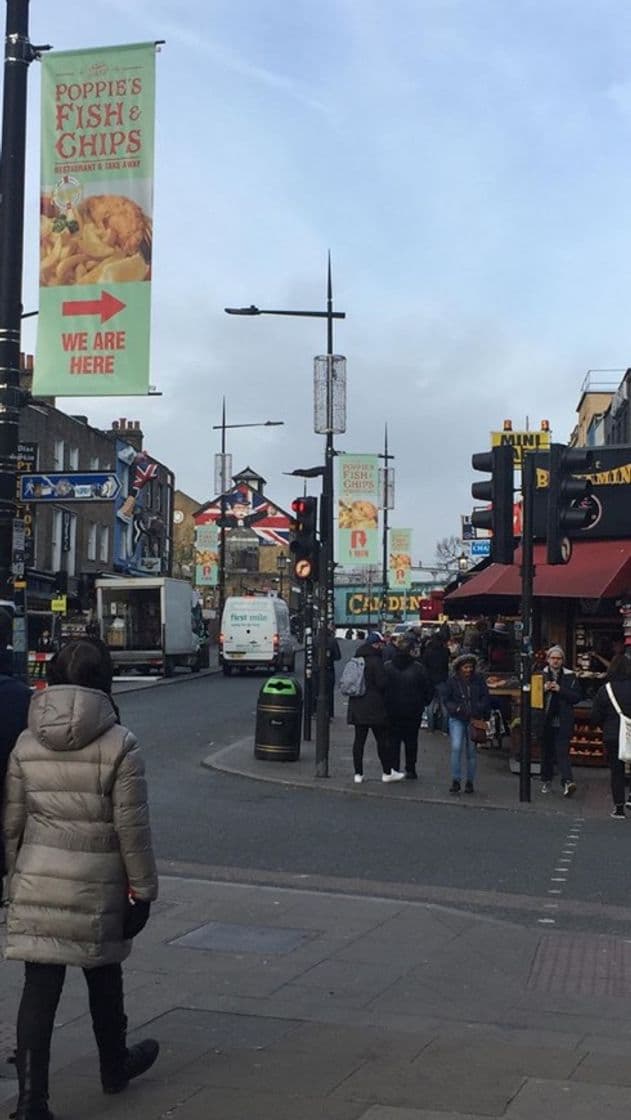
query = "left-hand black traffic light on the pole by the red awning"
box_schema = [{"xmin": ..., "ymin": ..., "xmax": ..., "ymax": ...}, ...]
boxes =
[{"xmin": 471, "ymin": 444, "xmax": 514, "ymax": 563}]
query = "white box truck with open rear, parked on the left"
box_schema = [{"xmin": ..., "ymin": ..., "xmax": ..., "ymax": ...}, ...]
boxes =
[{"xmin": 95, "ymin": 576, "xmax": 208, "ymax": 676}]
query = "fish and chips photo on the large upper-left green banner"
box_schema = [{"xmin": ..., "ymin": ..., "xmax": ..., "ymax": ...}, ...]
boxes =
[{"xmin": 39, "ymin": 194, "xmax": 152, "ymax": 288}]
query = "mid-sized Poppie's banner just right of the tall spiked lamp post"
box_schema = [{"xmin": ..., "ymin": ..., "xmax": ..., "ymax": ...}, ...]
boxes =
[{"xmin": 337, "ymin": 455, "xmax": 379, "ymax": 568}]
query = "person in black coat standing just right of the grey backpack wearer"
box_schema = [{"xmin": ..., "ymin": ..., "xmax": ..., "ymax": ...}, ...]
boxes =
[{"xmin": 386, "ymin": 637, "xmax": 434, "ymax": 781}]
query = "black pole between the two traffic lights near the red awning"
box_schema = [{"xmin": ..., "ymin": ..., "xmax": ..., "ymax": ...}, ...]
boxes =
[{"xmin": 519, "ymin": 452, "xmax": 535, "ymax": 801}]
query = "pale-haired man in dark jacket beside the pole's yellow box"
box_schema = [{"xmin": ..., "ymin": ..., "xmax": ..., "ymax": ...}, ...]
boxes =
[{"xmin": 541, "ymin": 645, "xmax": 581, "ymax": 797}]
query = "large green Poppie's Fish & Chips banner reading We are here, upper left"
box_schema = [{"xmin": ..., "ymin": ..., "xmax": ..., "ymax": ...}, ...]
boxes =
[{"xmin": 34, "ymin": 43, "xmax": 156, "ymax": 396}]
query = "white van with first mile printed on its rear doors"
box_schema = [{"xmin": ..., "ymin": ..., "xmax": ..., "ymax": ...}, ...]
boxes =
[{"xmin": 219, "ymin": 596, "xmax": 296, "ymax": 676}]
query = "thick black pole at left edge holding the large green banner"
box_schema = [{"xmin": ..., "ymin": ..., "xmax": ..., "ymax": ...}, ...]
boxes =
[{"xmin": 0, "ymin": 0, "xmax": 36, "ymax": 679}]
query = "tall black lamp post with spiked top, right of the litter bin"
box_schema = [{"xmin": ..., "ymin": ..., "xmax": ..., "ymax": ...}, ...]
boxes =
[{"xmin": 224, "ymin": 253, "xmax": 346, "ymax": 777}]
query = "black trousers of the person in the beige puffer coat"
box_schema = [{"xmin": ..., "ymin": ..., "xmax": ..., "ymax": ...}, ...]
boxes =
[{"xmin": 18, "ymin": 961, "xmax": 127, "ymax": 1054}]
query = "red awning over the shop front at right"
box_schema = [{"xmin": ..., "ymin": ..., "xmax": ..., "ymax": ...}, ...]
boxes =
[{"xmin": 446, "ymin": 540, "xmax": 631, "ymax": 603}]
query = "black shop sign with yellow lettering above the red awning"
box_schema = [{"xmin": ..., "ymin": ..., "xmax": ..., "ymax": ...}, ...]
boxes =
[{"xmin": 535, "ymin": 444, "xmax": 631, "ymax": 540}]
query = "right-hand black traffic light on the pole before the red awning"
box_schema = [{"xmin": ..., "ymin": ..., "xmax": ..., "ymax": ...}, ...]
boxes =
[{"xmin": 546, "ymin": 444, "xmax": 594, "ymax": 564}]
